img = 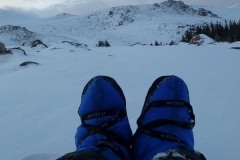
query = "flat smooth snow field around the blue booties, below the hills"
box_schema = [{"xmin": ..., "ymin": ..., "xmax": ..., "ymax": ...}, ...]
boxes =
[{"xmin": 0, "ymin": 42, "xmax": 240, "ymax": 160}]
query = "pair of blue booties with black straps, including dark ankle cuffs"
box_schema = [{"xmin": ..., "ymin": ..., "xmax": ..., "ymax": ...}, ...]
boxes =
[{"xmin": 58, "ymin": 76, "xmax": 205, "ymax": 160}]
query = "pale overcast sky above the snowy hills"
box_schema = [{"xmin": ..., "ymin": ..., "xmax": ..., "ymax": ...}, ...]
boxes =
[{"xmin": 0, "ymin": 0, "xmax": 240, "ymax": 17}]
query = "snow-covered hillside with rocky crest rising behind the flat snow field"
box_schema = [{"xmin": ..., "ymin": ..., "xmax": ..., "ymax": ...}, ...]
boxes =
[{"xmin": 0, "ymin": 0, "xmax": 240, "ymax": 46}]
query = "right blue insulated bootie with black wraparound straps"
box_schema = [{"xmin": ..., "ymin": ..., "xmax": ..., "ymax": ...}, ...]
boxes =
[{"xmin": 132, "ymin": 76, "xmax": 195, "ymax": 160}]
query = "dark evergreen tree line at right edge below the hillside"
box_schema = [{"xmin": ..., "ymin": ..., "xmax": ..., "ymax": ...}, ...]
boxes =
[{"xmin": 181, "ymin": 20, "xmax": 240, "ymax": 43}]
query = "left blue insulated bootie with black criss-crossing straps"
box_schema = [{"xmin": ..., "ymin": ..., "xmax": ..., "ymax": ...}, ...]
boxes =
[{"xmin": 75, "ymin": 76, "xmax": 132, "ymax": 160}]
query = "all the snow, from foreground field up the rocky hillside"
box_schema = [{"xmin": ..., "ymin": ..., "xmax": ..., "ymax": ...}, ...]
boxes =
[{"xmin": 0, "ymin": 0, "xmax": 240, "ymax": 160}]
